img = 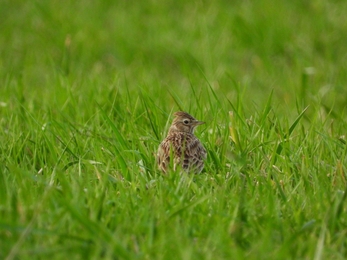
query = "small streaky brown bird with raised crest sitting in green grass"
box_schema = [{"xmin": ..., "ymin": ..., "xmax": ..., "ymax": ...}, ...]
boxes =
[{"xmin": 157, "ymin": 111, "xmax": 207, "ymax": 174}]
